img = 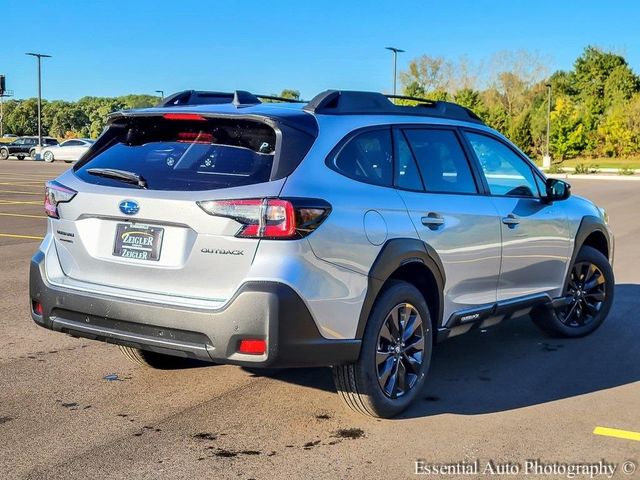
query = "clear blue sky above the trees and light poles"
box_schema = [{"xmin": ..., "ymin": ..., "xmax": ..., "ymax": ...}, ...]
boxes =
[{"xmin": 0, "ymin": 0, "xmax": 640, "ymax": 100}]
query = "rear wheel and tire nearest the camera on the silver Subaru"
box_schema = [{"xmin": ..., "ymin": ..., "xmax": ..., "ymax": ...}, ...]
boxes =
[{"xmin": 333, "ymin": 280, "xmax": 433, "ymax": 418}]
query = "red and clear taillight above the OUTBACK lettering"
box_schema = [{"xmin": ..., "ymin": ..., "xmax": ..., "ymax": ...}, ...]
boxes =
[{"xmin": 198, "ymin": 198, "xmax": 331, "ymax": 240}]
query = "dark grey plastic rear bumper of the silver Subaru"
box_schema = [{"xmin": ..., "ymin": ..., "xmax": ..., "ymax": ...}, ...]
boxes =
[{"xmin": 29, "ymin": 251, "xmax": 360, "ymax": 367}]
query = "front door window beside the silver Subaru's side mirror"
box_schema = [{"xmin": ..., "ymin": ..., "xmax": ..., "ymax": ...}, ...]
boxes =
[{"xmin": 465, "ymin": 132, "xmax": 538, "ymax": 197}]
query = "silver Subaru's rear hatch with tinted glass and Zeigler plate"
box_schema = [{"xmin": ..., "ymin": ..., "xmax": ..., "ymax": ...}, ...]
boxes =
[{"xmin": 51, "ymin": 113, "xmax": 314, "ymax": 301}]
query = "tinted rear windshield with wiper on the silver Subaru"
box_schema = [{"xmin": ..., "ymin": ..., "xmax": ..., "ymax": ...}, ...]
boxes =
[{"xmin": 75, "ymin": 115, "xmax": 276, "ymax": 190}]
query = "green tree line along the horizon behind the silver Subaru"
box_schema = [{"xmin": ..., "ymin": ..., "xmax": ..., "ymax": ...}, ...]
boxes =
[{"xmin": 4, "ymin": 46, "xmax": 640, "ymax": 164}]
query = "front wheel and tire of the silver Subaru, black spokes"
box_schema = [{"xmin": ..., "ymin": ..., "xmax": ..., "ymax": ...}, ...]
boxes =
[{"xmin": 531, "ymin": 246, "xmax": 615, "ymax": 338}]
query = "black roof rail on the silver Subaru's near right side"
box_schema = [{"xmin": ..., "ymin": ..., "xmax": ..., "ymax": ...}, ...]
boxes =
[{"xmin": 304, "ymin": 90, "xmax": 484, "ymax": 125}]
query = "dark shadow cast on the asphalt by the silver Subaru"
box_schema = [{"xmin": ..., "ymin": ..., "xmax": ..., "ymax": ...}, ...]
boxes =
[{"xmin": 258, "ymin": 284, "xmax": 640, "ymax": 418}]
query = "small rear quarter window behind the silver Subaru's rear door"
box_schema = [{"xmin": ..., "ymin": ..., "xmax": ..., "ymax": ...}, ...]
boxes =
[{"xmin": 332, "ymin": 129, "xmax": 393, "ymax": 187}]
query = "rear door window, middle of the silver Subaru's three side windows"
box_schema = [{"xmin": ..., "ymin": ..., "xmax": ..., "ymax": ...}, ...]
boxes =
[{"xmin": 405, "ymin": 129, "xmax": 478, "ymax": 193}]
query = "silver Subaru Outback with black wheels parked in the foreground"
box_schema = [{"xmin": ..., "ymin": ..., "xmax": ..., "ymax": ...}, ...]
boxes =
[{"xmin": 30, "ymin": 90, "xmax": 614, "ymax": 417}]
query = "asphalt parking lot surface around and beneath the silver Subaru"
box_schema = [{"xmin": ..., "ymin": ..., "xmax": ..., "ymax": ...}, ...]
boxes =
[{"xmin": 0, "ymin": 160, "xmax": 640, "ymax": 479}]
